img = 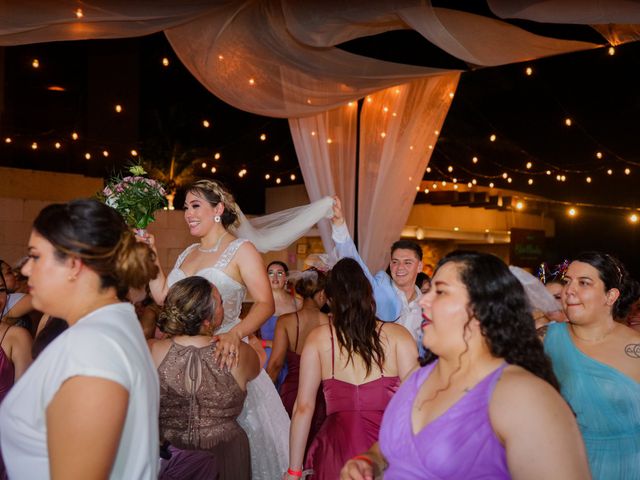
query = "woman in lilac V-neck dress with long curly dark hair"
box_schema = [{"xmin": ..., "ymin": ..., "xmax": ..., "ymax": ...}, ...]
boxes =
[{"xmin": 340, "ymin": 252, "xmax": 590, "ymax": 480}]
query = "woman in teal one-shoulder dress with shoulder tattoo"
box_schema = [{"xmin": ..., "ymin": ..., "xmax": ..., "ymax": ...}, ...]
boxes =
[{"xmin": 544, "ymin": 252, "xmax": 640, "ymax": 480}]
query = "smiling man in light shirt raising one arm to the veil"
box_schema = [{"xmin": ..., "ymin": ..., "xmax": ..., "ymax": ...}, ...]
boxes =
[{"xmin": 331, "ymin": 197, "xmax": 422, "ymax": 342}]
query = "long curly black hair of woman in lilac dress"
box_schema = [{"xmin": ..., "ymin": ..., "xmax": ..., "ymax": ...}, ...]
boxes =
[{"xmin": 429, "ymin": 250, "xmax": 559, "ymax": 390}]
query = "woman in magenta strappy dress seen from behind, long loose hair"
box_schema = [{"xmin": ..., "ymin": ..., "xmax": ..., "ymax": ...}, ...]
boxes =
[{"xmin": 285, "ymin": 258, "xmax": 417, "ymax": 480}]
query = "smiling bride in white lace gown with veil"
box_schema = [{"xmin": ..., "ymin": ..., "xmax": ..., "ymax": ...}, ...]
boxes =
[{"xmin": 145, "ymin": 180, "xmax": 331, "ymax": 479}]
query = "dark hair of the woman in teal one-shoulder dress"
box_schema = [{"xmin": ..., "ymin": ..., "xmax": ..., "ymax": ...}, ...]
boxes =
[{"xmin": 573, "ymin": 252, "xmax": 640, "ymax": 320}]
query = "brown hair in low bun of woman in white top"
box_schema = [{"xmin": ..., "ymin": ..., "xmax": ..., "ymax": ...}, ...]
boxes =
[{"xmin": 33, "ymin": 199, "xmax": 158, "ymax": 299}]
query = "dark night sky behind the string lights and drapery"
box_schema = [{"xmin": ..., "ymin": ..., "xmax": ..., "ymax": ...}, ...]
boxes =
[{"xmin": 0, "ymin": 15, "xmax": 640, "ymax": 271}]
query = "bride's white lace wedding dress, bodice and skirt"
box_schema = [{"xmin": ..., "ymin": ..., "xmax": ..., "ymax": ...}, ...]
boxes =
[{"xmin": 167, "ymin": 238, "xmax": 290, "ymax": 480}]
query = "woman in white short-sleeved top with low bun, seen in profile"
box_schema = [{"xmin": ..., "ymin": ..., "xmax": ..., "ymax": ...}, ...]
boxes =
[{"xmin": 0, "ymin": 200, "xmax": 159, "ymax": 480}]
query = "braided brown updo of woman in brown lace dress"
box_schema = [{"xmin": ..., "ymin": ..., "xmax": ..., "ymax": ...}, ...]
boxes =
[{"xmin": 158, "ymin": 276, "xmax": 218, "ymax": 336}]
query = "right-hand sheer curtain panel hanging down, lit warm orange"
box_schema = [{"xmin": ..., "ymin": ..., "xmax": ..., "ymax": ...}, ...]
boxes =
[{"xmin": 358, "ymin": 73, "xmax": 459, "ymax": 271}]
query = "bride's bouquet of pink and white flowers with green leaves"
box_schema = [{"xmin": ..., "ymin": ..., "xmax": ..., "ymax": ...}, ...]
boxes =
[{"xmin": 98, "ymin": 165, "xmax": 167, "ymax": 230}]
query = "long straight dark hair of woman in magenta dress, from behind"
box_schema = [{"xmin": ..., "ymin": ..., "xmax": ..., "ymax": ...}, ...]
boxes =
[{"xmin": 325, "ymin": 258, "xmax": 384, "ymax": 375}]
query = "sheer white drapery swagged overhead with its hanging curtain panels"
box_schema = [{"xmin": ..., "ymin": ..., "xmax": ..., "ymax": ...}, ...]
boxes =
[{"xmin": 0, "ymin": 0, "xmax": 640, "ymax": 262}]
